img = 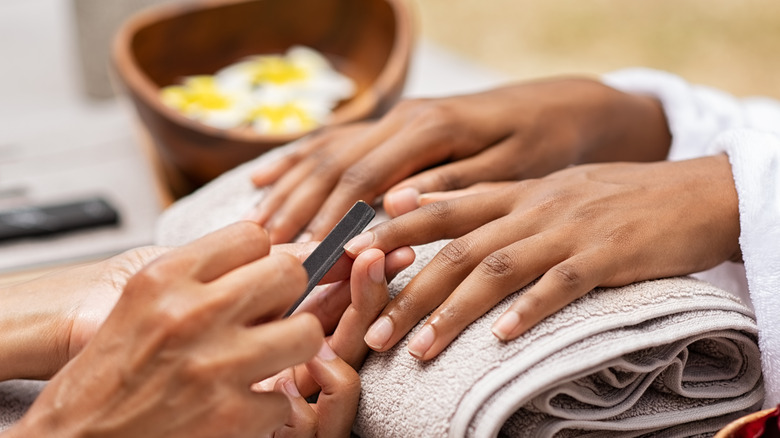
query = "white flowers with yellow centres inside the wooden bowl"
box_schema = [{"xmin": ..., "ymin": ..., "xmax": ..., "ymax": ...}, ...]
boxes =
[{"xmin": 162, "ymin": 46, "xmax": 355, "ymax": 134}]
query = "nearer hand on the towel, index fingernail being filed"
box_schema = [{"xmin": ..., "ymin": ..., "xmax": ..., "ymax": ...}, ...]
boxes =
[{"xmin": 347, "ymin": 155, "xmax": 739, "ymax": 360}]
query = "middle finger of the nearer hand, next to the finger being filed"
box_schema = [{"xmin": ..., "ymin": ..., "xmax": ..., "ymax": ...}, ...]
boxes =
[{"xmin": 365, "ymin": 212, "xmax": 534, "ymax": 352}]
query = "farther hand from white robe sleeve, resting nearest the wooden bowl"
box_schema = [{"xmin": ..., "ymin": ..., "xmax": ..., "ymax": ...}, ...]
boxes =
[{"xmin": 248, "ymin": 79, "xmax": 670, "ymax": 243}]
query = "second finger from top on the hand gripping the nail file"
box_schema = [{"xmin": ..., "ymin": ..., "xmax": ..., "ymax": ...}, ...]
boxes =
[{"xmin": 212, "ymin": 254, "xmax": 308, "ymax": 325}]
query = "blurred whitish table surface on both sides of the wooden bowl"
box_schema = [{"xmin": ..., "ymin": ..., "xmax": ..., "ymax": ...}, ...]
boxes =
[{"xmin": 0, "ymin": 0, "xmax": 506, "ymax": 285}]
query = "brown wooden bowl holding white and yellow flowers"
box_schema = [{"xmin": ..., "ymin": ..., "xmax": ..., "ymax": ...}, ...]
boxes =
[{"xmin": 113, "ymin": 0, "xmax": 413, "ymax": 197}]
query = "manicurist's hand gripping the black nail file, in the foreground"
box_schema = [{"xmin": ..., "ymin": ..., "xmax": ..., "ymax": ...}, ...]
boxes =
[{"xmin": 12, "ymin": 222, "xmax": 323, "ymax": 437}]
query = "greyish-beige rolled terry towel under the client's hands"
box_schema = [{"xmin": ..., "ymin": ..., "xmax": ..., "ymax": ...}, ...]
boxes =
[{"xmin": 156, "ymin": 145, "xmax": 764, "ymax": 437}]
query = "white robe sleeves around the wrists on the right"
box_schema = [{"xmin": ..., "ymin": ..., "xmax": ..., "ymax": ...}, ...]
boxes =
[{"xmin": 603, "ymin": 68, "xmax": 780, "ymax": 407}]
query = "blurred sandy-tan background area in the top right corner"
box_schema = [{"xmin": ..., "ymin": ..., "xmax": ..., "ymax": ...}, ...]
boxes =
[{"xmin": 416, "ymin": 0, "xmax": 780, "ymax": 97}]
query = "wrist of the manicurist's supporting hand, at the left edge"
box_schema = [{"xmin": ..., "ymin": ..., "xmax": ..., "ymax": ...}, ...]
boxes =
[{"xmin": 0, "ymin": 247, "xmax": 167, "ymax": 380}]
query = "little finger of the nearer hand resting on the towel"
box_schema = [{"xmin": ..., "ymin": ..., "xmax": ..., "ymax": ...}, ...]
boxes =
[{"xmin": 492, "ymin": 254, "xmax": 608, "ymax": 341}]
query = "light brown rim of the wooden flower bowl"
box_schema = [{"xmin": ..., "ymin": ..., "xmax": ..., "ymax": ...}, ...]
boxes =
[{"xmin": 112, "ymin": 0, "xmax": 414, "ymax": 144}]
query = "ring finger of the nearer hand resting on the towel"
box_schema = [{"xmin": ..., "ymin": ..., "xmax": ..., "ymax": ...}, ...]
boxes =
[{"xmin": 408, "ymin": 233, "xmax": 570, "ymax": 360}]
